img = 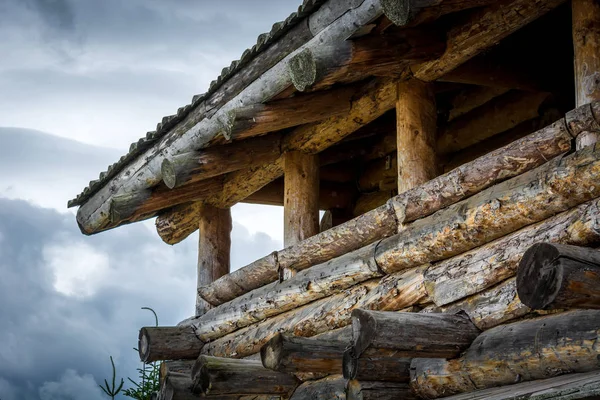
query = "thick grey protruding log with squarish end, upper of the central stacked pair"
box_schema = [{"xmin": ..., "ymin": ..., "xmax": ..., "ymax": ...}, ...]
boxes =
[{"xmin": 352, "ymin": 309, "xmax": 479, "ymax": 358}]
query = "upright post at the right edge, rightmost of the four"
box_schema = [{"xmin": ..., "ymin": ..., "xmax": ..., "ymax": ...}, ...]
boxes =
[{"xmin": 572, "ymin": 0, "xmax": 600, "ymax": 149}]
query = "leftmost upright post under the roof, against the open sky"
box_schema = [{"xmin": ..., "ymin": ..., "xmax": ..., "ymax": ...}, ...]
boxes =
[{"xmin": 196, "ymin": 204, "xmax": 232, "ymax": 315}]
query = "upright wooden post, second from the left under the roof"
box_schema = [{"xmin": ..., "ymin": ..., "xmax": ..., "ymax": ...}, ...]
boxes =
[{"xmin": 283, "ymin": 151, "xmax": 319, "ymax": 247}]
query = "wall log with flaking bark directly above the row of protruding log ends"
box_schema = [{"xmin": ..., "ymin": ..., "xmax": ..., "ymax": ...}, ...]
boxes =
[{"xmin": 203, "ymin": 267, "xmax": 429, "ymax": 357}]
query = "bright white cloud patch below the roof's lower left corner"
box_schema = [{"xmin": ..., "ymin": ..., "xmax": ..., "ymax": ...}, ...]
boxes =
[{"xmin": 43, "ymin": 242, "xmax": 109, "ymax": 297}]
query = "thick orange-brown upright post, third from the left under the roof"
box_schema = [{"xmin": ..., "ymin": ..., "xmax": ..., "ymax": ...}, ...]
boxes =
[{"xmin": 396, "ymin": 79, "xmax": 439, "ymax": 193}]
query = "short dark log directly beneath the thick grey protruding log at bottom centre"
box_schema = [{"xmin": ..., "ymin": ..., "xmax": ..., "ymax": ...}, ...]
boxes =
[{"xmin": 342, "ymin": 347, "xmax": 411, "ymax": 383}]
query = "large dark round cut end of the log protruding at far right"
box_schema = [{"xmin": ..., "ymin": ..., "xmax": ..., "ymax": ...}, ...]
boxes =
[{"xmin": 517, "ymin": 243, "xmax": 562, "ymax": 310}]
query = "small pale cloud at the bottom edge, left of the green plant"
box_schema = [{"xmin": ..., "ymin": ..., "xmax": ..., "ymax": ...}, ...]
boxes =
[{"xmin": 39, "ymin": 369, "xmax": 106, "ymax": 400}]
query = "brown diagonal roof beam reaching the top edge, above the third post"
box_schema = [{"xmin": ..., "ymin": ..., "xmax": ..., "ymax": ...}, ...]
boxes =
[{"xmin": 412, "ymin": 0, "xmax": 564, "ymax": 81}]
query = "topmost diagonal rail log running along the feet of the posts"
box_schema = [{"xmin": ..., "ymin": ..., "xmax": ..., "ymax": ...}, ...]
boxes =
[{"xmin": 197, "ymin": 104, "xmax": 580, "ymax": 305}]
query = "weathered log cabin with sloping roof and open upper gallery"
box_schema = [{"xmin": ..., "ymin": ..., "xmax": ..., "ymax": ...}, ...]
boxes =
[{"xmin": 69, "ymin": 0, "xmax": 600, "ymax": 400}]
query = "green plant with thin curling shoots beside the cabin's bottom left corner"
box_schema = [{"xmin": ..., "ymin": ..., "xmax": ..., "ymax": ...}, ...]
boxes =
[{"xmin": 99, "ymin": 307, "xmax": 160, "ymax": 400}]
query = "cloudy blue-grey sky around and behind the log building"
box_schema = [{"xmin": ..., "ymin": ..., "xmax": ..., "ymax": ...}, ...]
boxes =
[{"xmin": 0, "ymin": 0, "xmax": 299, "ymax": 400}]
